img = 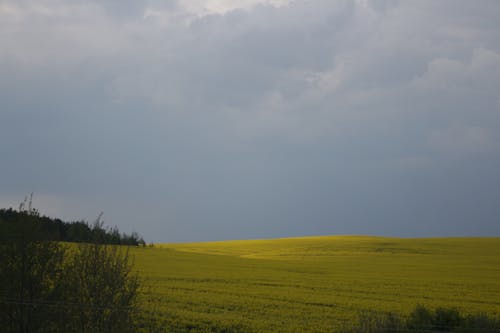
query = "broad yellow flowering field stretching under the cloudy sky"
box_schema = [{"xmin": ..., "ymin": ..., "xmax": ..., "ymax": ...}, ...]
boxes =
[{"xmin": 133, "ymin": 236, "xmax": 500, "ymax": 332}]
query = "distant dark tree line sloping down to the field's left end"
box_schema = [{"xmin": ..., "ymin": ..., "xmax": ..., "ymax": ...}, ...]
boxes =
[{"xmin": 0, "ymin": 205, "xmax": 145, "ymax": 246}]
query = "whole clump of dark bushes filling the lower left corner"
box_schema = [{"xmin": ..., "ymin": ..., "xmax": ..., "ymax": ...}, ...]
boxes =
[{"xmin": 0, "ymin": 210, "xmax": 150, "ymax": 332}]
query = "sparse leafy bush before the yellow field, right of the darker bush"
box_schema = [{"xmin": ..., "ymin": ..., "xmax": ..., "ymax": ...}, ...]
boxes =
[{"xmin": 58, "ymin": 243, "xmax": 140, "ymax": 332}]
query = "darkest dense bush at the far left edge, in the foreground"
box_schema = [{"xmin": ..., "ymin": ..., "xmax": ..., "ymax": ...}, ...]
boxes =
[{"xmin": 0, "ymin": 212, "xmax": 66, "ymax": 332}]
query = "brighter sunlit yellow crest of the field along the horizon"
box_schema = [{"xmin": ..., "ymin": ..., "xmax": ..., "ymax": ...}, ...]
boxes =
[{"xmin": 159, "ymin": 236, "xmax": 500, "ymax": 260}]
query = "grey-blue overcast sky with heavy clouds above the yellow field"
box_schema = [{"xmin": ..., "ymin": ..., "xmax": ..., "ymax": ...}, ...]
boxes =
[{"xmin": 0, "ymin": 0, "xmax": 500, "ymax": 242}]
